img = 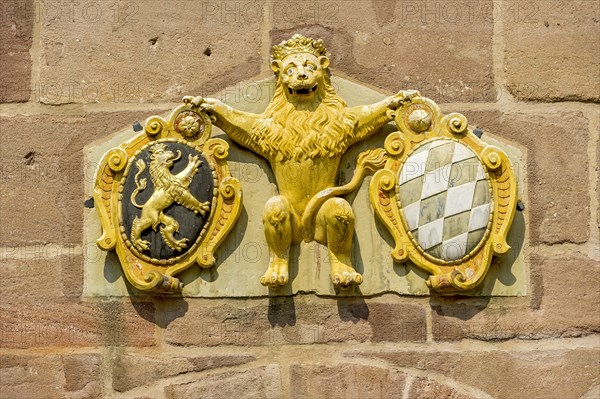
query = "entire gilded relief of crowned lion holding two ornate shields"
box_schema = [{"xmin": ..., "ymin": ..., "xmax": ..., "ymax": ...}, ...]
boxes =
[{"xmin": 95, "ymin": 35, "xmax": 517, "ymax": 292}]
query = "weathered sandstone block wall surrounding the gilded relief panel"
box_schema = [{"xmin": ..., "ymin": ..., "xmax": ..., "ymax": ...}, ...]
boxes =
[{"xmin": 0, "ymin": 0, "xmax": 600, "ymax": 399}]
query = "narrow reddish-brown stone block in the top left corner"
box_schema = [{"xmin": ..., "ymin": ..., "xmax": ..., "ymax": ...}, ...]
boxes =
[{"xmin": 0, "ymin": 0, "xmax": 35, "ymax": 103}]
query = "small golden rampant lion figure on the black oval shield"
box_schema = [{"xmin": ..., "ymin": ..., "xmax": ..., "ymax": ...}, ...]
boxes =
[{"xmin": 131, "ymin": 143, "xmax": 210, "ymax": 252}]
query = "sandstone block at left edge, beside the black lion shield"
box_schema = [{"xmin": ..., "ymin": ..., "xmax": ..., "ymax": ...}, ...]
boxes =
[{"xmin": 0, "ymin": 109, "xmax": 170, "ymax": 247}]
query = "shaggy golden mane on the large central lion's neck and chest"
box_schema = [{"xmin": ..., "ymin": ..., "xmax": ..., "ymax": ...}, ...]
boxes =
[{"xmin": 252, "ymin": 75, "xmax": 356, "ymax": 161}]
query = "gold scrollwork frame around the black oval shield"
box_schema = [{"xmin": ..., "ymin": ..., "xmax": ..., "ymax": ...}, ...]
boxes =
[{"xmin": 93, "ymin": 101, "xmax": 242, "ymax": 293}]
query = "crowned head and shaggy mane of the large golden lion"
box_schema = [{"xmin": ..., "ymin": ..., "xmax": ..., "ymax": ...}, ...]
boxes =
[{"xmin": 253, "ymin": 35, "xmax": 356, "ymax": 161}]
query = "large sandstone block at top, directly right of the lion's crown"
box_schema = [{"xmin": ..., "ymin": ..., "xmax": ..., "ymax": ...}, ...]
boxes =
[{"xmin": 270, "ymin": 0, "xmax": 496, "ymax": 103}]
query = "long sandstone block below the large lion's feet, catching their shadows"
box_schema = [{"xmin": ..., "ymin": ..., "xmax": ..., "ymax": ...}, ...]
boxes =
[{"xmin": 164, "ymin": 296, "xmax": 426, "ymax": 346}]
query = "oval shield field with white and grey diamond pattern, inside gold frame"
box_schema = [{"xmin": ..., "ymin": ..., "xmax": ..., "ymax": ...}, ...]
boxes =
[{"xmin": 398, "ymin": 139, "xmax": 493, "ymax": 261}]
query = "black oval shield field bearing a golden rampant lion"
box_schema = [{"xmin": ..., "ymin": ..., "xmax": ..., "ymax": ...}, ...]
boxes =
[{"xmin": 119, "ymin": 140, "xmax": 215, "ymax": 263}]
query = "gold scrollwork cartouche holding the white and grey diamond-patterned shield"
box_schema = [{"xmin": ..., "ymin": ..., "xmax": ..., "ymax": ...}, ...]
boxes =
[{"xmin": 370, "ymin": 98, "xmax": 517, "ymax": 292}]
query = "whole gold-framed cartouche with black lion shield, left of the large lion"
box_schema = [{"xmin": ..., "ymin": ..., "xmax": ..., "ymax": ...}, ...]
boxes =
[{"xmin": 94, "ymin": 101, "xmax": 242, "ymax": 293}]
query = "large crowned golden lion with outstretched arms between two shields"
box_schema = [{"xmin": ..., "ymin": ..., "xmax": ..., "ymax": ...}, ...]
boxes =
[{"xmin": 184, "ymin": 35, "xmax": 418, "ymax": 288}]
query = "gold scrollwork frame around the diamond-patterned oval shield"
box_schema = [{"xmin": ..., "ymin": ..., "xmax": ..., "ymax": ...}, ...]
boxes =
[{"xmin": 369, "ymin": 97, "xmax": 517, "ymax": 292}]
